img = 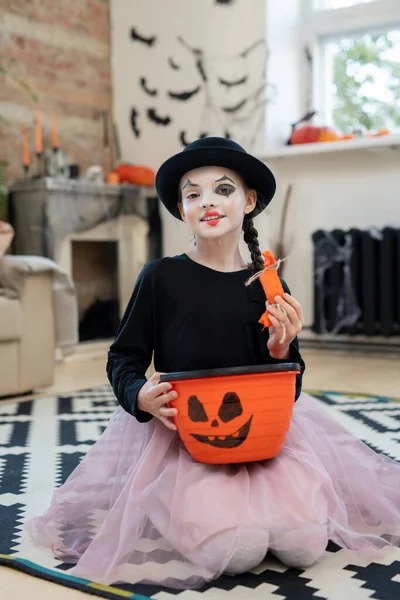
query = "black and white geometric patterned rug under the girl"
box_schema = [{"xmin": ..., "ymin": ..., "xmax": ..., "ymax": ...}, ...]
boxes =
[{"xmin": 0, "ymin": 386, "xmax": 400, "ymax": 600}]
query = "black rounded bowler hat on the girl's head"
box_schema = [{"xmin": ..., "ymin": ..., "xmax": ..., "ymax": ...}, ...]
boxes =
[{"xmin": 156, "ymin": 137, "xmax": 276, "ymax": 219}]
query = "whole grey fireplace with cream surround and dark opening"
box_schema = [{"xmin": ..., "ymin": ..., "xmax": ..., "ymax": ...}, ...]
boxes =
[{"xmin": 9, "ymin": 177, "xmax": 162, "ymax": 337}]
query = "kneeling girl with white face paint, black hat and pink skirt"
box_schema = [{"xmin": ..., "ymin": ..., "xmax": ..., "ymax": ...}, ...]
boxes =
[{"xmin": 30, "ymin": 138, "xmax": 400, "ymax": 588}]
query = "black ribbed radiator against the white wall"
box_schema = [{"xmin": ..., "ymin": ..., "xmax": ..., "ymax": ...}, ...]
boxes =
[{"xmin": 312, "ymin": 227, "xmax": 400, "ymax": 336}]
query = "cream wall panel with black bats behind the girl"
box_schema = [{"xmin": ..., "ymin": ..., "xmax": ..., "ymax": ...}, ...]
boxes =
[{"xmin": 111, "ymin": 0, "xmax": 266, "ymax": 255}]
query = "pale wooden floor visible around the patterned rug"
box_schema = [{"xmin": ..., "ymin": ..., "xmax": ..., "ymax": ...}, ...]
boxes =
[{"xmin": 0, "ymin": 343, "xmax": 400, "ymax": 600}]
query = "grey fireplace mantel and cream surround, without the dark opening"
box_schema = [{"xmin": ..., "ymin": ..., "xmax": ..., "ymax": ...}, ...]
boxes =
[{"xmin": 10, "ymin": 178, "xmax": 153, "ymax": 316}]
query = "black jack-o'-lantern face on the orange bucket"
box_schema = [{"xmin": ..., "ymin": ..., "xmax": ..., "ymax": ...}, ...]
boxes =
[{"xmin": 188, "ymin": 392, "xmax": 253, "ymax": 448}]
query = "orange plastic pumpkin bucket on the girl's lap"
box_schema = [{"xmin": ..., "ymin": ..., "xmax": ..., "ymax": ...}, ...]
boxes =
[{"xmin": 161, "ymin": 363, "xmax": 300, "ymax": 464}]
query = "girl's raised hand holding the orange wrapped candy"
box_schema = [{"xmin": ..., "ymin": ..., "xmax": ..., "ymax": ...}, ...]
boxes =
[{"xmin": 266, "ymin": 294, "xmax": 304, "ymax": 360}]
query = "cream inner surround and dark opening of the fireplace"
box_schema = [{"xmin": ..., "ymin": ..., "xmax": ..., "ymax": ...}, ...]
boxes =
[{"xmin": 56, "ymin": 215, "xmax": 149, "ymax": 342}]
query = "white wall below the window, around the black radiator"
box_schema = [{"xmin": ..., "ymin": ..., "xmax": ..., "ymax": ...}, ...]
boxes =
[{"xmin": 267, "ymin": 149, "xmax": 400, "ymax": 325}]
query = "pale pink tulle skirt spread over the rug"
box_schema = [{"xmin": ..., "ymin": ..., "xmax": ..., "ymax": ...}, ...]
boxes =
[{"xmin": 27, "ymin": 394, "xmax": 400, "ymax": 588}]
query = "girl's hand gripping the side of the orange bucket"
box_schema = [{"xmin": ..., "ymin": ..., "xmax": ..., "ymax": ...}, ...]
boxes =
[{"xmin": 137, "ymin": 373, "xmax": 178, "ymax": 431}]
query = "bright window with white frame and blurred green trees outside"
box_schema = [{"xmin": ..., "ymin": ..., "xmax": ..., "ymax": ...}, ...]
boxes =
[{"xmin": 304, "ymin": 0, "xmax": 400, "ymax": 133}]
